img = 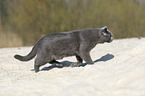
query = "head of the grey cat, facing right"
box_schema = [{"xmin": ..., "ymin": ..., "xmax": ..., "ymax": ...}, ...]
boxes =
[{"xmin": 100, "ymin": 26, "xmax": 113, "ymax": 43}]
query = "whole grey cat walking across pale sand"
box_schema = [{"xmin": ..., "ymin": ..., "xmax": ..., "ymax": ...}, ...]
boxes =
[{"xmin": 14, "ymin": 26, "xmax": 113, "ymax": 72}]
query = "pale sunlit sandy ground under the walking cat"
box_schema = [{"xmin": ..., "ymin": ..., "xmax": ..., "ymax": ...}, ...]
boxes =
[{"xmin": 0, "ymin": 38, "xmax": 145, "ymax": 96}]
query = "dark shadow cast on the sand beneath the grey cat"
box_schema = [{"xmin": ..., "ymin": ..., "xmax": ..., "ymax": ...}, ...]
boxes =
[{"xmin": 38, "ymin": 54, "xmax": 114, "ymax": 71}]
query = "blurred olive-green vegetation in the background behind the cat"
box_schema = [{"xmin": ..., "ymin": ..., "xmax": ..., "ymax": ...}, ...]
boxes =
[{"xmin": 0, "ymin": 0, "xmax": 145, "ymax": 46}]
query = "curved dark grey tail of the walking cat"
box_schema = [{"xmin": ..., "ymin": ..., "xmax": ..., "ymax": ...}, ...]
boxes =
[{"xmin": 14, "ymin": 44, "xmax": 37, "ymax": 61}]
